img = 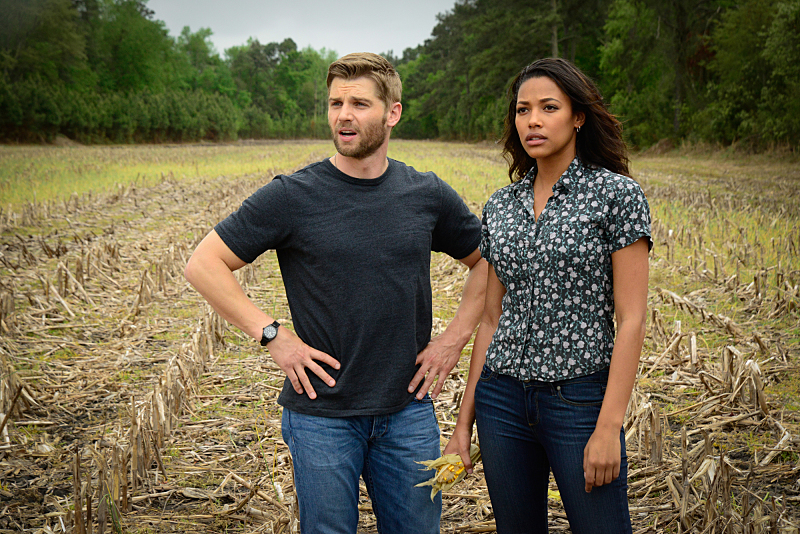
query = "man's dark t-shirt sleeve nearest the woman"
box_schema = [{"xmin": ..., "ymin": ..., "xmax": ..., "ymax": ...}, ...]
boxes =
[{"xmin": 431, "ymin": 178, "xmax": 481, "ymax": 260}]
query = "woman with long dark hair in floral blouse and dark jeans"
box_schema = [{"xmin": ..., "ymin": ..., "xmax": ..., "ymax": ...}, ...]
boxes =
[{"xmin": 445, "ymin": 58, "xmax": 652, "ymax": 534}]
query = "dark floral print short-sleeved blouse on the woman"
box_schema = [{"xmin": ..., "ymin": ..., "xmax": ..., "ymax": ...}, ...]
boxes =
[{"xmin": 480, "ymin": 158, "xmax": 652, "ymax": 382}]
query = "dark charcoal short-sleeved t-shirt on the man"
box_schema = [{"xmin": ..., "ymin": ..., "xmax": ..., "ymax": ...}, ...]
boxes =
[{"xmin": 216, "ymin": 159, "xmax": 480, "ymax": 417}]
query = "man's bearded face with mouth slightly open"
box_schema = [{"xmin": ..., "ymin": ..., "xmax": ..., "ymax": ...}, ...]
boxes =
[{"xmin": 328, "ymin": 77, "xmax": 391, "ymax": 159}]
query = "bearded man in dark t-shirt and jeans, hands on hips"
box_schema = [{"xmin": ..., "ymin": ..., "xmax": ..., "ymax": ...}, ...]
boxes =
[{"xmin": 186, "ymin": 54, "xmax": 487, "ymax": 534}]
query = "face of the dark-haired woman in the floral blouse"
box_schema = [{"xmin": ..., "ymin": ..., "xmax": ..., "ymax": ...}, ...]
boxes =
[{"xmin": 514, "ymin": 76, "xmax": 584, "ymax": 166}]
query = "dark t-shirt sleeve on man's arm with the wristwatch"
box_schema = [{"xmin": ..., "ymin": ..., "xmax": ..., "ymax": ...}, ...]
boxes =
[{"xmin": 214, "ymin": 176, "xmax": 292, "ymax": 263}]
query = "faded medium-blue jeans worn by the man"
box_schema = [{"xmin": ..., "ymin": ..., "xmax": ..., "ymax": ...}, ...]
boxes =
[{"xmin": 281, "ymin": 396, "xmax": 442, "ymax": 534}]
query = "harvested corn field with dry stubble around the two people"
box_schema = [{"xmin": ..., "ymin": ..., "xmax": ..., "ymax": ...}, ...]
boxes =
[{"xmin": 0, "ymin": 141, "xmax": 800, "ymax": 534}]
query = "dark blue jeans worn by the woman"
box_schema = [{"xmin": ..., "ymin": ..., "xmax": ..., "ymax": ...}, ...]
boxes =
[{"xmin": 475, "ymin": 366, "xmax": 631, "ymax": 534}]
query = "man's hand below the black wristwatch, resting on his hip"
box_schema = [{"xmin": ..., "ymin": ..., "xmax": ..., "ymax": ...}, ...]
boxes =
[{"xmin": 267, "ymin": 326, "xmax": 340, "ymax": 399}]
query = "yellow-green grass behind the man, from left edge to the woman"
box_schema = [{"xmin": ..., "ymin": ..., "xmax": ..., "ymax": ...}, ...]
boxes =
[{"xmin": 0, "ymin": 140, "xmax": 508, "ymax": 218}]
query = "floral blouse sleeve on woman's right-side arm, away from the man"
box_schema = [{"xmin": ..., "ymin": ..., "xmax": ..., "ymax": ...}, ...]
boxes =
[{"xmin": 607, "ymin": 176, "xmax": 653, "ymax": 252}]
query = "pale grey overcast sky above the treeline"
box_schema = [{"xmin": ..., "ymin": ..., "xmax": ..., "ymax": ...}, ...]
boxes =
[{"xmin": 147, "ymin": 0, "xmax": 456, "ymax": 56}]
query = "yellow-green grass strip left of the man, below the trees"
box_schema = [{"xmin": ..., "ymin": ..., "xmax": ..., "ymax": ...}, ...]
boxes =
[{"xmin": 0, "ymin": 141, "xmax": 333, "ymax": 210}]
